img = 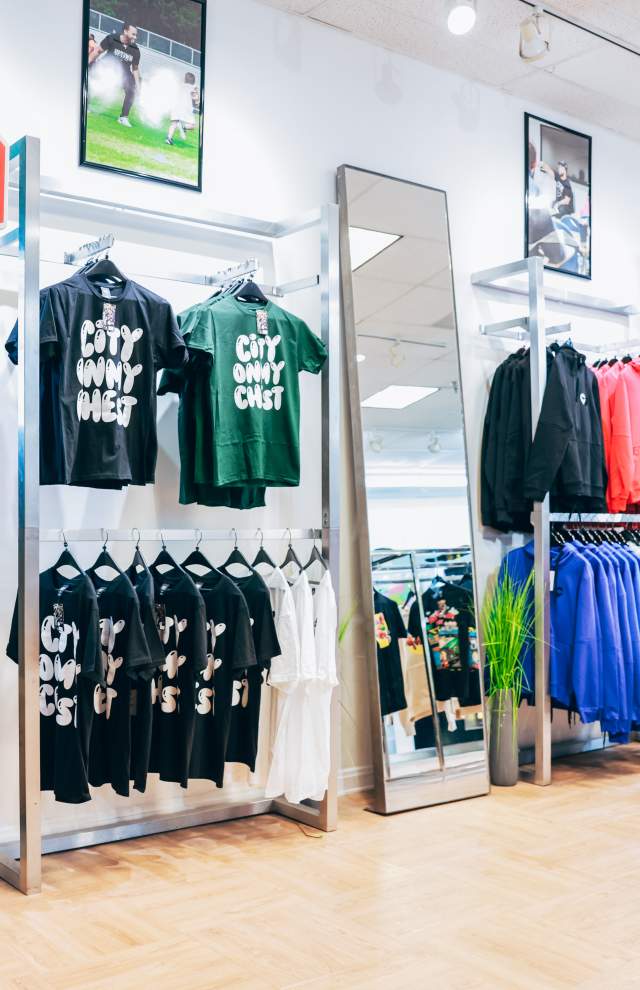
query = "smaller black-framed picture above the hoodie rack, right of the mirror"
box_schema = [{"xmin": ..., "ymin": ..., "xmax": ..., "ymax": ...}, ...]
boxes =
[{"xmin": 524, "ymin": 113, "xmax": 592, "ymax": 278}]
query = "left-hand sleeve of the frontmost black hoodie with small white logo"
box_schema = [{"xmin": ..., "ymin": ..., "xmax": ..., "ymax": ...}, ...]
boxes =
[{"xmin": 524, "ymin": 355, "xmax": 575, "ymax": 502}]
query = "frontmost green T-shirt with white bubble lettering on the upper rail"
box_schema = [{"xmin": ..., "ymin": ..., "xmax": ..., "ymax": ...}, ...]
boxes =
[{"xmin": 181, "ymin": 296, "xmax": 327, "ymax": 487}]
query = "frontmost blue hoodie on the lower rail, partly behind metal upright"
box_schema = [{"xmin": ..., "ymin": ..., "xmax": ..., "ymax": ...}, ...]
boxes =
[{"xmin": 500, "ymin": 543, "xmax": 602, "ymax": 721}]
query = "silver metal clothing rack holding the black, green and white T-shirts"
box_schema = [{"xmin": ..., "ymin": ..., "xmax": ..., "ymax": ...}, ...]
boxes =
[{"xmin": 0, "ymin": 137, "xmax": 341, "ymax": 894}]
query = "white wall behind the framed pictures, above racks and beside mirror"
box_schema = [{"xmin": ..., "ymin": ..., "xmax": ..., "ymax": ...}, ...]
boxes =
[{"xmin": 0, "ymin": 0, "xmax": 640, "ymax": 812}]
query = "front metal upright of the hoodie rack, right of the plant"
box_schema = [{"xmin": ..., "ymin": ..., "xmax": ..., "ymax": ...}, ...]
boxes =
[{"xmin": 529, "ymin": 258, "xmax": 551, "ymax": 785}]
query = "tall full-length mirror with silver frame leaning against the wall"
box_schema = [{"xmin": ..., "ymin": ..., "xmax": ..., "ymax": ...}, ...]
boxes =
[{"xmin": 338, "ymin": 166, "xmax": 489, "ymax": 814}]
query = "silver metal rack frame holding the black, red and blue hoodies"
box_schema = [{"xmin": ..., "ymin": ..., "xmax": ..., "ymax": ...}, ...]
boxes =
[{"xmin": 471, "ymin": 258, "xmax": 640, "ymax": 786}]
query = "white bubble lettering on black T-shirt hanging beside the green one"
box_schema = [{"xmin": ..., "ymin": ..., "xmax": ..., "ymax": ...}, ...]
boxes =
[{"xmin": 76, "ymin": 303, "xmax": 144, "ymax": 429}]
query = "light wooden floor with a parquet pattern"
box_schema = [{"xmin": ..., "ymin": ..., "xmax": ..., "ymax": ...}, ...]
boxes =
[{"xmin": 0, "ymin": 746, "xmax": 640, "ymax": 990}]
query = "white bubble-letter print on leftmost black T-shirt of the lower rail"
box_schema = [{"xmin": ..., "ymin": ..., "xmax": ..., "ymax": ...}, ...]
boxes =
[{"xmin": 40, "ymin": 606, "xmax": 81, "ymax": 726}]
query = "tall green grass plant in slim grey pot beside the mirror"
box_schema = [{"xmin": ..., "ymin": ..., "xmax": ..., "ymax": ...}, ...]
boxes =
[{"xmin": 482, "ymin": 572, "xmax": 534, "ymax": 787}]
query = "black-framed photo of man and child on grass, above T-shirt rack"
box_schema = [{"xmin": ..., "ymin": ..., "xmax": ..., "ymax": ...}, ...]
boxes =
[{"xmin": 80, "ymin": 0, "xmax": 206, "ymax": 190}]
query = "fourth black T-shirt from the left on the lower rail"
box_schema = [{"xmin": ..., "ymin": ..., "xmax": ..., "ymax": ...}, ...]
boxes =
[{"xmin": 150, "ymin": 565, "xmax": 207, "ymax": 787}]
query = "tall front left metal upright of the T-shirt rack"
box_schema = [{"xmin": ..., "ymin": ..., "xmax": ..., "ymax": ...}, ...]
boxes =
[{"xmin": 12, "ymin": 137, "xmax": 41, "ymax": 894}]
